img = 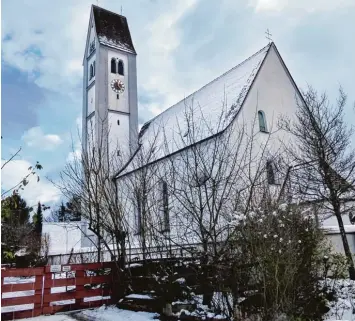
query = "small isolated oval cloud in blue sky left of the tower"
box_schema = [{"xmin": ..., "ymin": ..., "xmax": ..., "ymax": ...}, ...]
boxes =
[{"xmin": 22, "ymin": 127, "xmax": 63, "ymax": 150}]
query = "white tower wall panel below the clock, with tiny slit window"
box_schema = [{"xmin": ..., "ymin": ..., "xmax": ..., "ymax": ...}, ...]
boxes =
[{"xmin": 108, "ymin": 112, "xmax": 129, "ymax": 157}]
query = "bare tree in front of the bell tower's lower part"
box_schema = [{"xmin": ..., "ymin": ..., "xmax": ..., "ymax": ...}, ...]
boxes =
[{"xmin": 52, "ymin": 119, "xmax": 129, "ymax": 264}]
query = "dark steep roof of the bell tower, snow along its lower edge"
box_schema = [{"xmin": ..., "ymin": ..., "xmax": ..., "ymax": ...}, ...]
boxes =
[{"xmin": 92, "ymin": 5, "xmax": 136, "ymax": 54}]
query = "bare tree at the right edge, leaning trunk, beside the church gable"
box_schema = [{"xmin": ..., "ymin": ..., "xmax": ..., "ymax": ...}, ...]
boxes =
[{"xmin": 280, "ymin": 87, "xmax": 355, "ymax": 279}]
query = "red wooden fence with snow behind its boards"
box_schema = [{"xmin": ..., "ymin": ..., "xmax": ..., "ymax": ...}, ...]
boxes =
[{"xmin": 1, "ymin": 262, "xmax": 117, "ymax": 320}]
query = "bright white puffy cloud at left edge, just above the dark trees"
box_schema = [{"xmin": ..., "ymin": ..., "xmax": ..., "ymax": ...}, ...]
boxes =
[{"xmin": 1, "ymin": 160, "xmax": 60, "ymax": 206}]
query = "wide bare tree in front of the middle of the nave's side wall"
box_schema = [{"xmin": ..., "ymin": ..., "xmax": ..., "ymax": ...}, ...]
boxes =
[{"xmin": 125, "ymin": 99, "xmax": 286, "ymax": 304}]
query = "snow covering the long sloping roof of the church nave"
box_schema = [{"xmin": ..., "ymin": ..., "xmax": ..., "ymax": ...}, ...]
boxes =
[{"xmin": 119, "ymin": 43, "xmax": 272, "ymax": 176}]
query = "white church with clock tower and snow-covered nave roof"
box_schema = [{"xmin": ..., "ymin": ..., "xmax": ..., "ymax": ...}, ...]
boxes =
[{"xmin": 82, "ymin": 5, "xmax": 355, "ymax": 258}]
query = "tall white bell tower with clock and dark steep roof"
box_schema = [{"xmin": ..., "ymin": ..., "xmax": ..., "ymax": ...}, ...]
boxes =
[{"xmin": 82, "ymin": 5, "xmax": 138, "ymax": 159}]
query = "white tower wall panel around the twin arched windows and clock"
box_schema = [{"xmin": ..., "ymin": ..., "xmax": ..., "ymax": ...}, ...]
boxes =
[{"xmin": 107, "ymin": 50, "xmax": 129, "ymax": 113}]
